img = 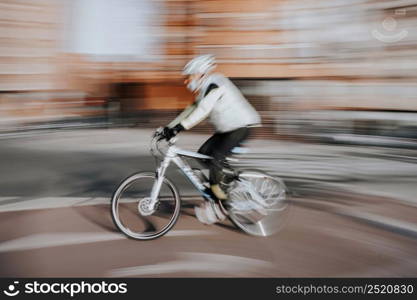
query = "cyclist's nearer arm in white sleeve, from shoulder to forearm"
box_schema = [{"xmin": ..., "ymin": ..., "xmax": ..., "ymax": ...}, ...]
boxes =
[{"xmin": 180, "ymin": 87, "xmax": 223, "ymax": 130}]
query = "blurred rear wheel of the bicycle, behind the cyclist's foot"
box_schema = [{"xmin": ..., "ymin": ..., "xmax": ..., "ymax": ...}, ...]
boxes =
[{"xmin": 228, "ymin": 170, "xmax": 289, "ymax": 236}]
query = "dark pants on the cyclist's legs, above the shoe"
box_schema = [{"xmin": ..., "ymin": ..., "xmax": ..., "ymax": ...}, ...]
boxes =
[{"xmin": 198, "ymin": 127, "xmax": 249, "ymax": 184}]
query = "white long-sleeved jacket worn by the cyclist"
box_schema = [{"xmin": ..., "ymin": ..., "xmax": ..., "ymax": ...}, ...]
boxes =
[{"xmin": 168, "ymin": 74, "xmax": 261, "ymax": 132}]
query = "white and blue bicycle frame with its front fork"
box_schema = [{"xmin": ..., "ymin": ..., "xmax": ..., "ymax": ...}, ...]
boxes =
[{"xmin": 149, "ymin": 145, "xmax": 213, "ymax": 209}]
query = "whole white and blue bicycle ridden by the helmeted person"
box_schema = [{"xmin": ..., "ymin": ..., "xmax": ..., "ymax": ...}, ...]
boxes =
[{"xmin": 111, "ymin": 129, "xmax": 289, "ymax": 240}]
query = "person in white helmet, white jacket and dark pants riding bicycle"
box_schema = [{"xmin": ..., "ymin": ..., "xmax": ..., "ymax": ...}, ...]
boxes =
[{"xmin": 163, "ymin": 55, "xmax": 261, "ymax": 218}]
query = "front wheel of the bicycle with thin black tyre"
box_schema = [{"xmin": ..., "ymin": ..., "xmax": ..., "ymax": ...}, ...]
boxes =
[{"xmin": 111, "ymin": 172, "xmax": 181, "ymax": 240}]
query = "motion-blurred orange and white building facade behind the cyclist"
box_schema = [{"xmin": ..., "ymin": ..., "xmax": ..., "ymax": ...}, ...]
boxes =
[{"xmin": 0, "ymin": 0, "xmax": 417, "ymax": 137}]
